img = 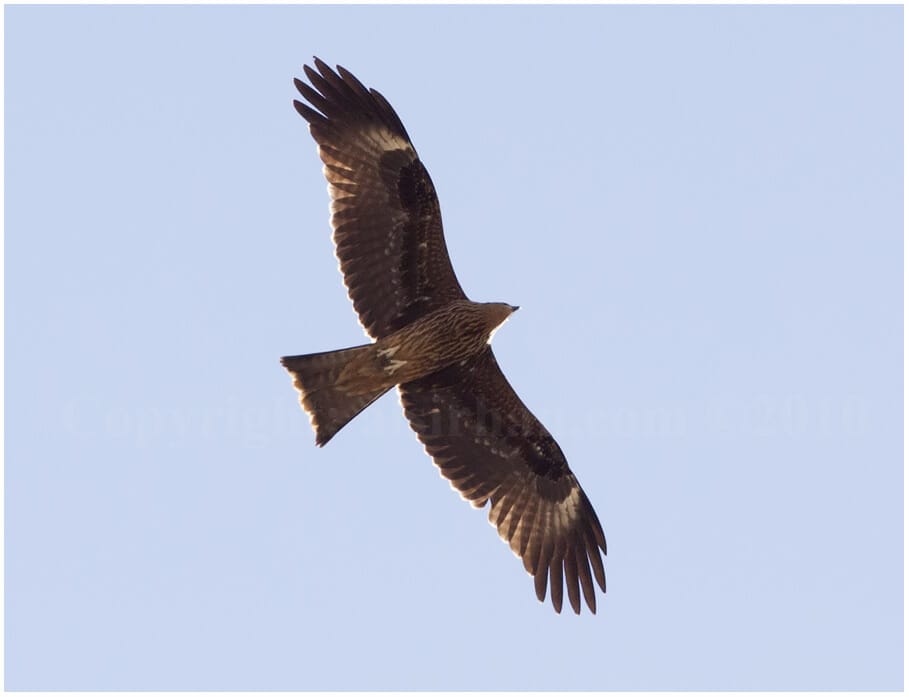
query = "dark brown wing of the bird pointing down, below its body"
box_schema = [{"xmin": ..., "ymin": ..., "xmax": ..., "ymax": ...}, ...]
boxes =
[{"xmin": 399, "ymin": 348, "xmax": 606, "ymax": 613}]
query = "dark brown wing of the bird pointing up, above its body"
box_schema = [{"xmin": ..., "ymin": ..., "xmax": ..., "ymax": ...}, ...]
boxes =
[{"xmin": 294, "ymin": 58, "xmax": 465, "ymax": 338}]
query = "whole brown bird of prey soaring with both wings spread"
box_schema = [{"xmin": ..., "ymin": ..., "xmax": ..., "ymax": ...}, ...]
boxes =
[{"xmin": 281, "ymin": 58, "xmax": 606, "ymax": 614}]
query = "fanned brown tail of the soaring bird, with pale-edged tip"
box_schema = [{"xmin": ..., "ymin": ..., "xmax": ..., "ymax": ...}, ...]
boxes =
[{"xmin": 281, "ymin": 344, "xmax": 392, "ymax": 446}]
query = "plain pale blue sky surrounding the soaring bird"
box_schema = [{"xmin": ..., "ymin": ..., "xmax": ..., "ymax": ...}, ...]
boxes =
[{"xmin": 5, "ymin": 6, "xmax": 903, "ymax": 690}]
